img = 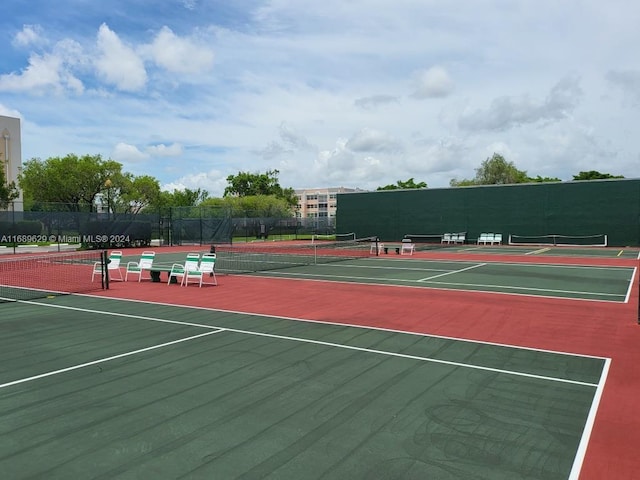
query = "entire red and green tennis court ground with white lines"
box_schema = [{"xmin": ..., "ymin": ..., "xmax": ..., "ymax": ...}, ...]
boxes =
[{"xmin": 0, "ymin": 247, "xmax": 640, "ymax": 480}]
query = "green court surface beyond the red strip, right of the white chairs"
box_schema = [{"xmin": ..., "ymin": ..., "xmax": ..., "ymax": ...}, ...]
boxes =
[{"xmin": 246, "ymin": 257, "xmax": 634, "ymax": 302}]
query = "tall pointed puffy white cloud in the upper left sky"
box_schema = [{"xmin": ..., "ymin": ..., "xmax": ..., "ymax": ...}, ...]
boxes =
[{"xmin": 94, "ymin": 23, "xmax": 147, "ymax": 92}]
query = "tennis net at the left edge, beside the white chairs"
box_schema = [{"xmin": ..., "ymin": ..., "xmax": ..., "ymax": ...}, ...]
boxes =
[{"xmin": 0, "ymin": 250, "xmax": 107, "ymax": 302}]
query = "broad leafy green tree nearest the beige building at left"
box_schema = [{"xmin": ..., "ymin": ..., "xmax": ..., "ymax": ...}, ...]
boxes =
[{"xmin": 18, "ymin": 154, "xmax": 123, "ymax": 211}]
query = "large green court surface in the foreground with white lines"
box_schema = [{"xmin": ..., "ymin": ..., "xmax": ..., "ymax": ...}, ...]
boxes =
[{"xmin": 0, "ymin": 295, "xmax": 609, "ymax": 480}]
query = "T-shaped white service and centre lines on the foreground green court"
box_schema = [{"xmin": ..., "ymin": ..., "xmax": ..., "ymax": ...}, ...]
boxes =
[{"xmin": 0, "ymin": 301, "xmax": 597, "ymax": 388}]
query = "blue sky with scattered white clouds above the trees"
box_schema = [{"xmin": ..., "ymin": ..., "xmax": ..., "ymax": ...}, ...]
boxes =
[{"xmin": 0, "ymin": 0, "xmax": 640, "ymax": 196}]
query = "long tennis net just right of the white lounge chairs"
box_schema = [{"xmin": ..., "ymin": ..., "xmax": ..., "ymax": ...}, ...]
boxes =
[{"xmin": 215, "ymin": 237, "xmax": 376, "ymax": 273}]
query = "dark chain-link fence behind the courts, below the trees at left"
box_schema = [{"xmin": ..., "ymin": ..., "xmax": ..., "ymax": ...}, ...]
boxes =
[{"xmin": 0, "ymin": 202, "xmax": 335, "ymax": 250}]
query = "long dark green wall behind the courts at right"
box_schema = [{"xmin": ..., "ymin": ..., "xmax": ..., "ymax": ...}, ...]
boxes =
[{"xmin": 336, "ymin": 179, "xmax": 640, "ymax": 246}]
